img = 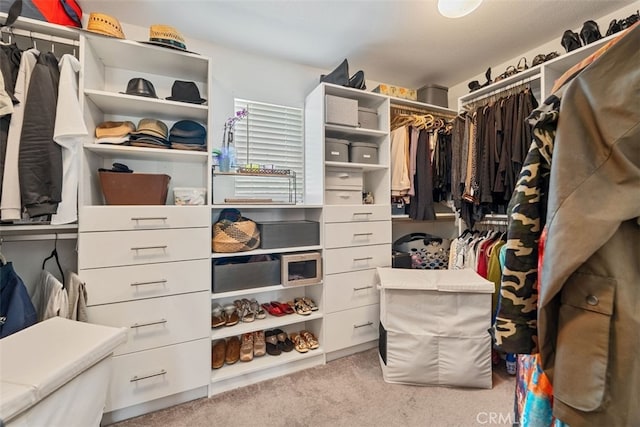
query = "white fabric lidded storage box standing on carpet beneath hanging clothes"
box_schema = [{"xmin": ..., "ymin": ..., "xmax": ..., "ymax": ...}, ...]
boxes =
[{"xmin": 377, "ymin": 267, "xmax": 494, "ymax": 388}]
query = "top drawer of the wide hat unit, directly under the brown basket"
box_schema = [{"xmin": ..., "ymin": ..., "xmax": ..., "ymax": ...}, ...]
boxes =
[{"xmin": 78, "ymin": 206, "xmax": 211, "ymax": 232}]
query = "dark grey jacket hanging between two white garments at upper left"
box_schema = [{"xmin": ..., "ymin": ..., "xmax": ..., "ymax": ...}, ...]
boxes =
[{"xmin": 18, "ymin": 52, "xmax": 62, "ymax": 218}]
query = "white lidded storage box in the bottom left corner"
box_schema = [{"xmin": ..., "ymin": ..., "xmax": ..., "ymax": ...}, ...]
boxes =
[{"xmin": 0, "ymin": 317, "xmax": 127, "ymax": 427}]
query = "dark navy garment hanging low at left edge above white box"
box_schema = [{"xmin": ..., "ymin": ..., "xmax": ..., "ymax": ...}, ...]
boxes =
[{"xmin": 0, "ymin": 262, "xmax": 37, "ymax": 338}]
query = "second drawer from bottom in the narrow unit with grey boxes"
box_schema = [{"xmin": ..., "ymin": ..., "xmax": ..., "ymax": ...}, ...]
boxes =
[{"xmin": 324, "ymin": 270, "xmax": 380, "ymax": 313}]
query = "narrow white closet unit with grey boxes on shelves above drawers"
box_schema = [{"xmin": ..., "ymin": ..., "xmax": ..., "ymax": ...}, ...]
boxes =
[{"xmin": 305, "ymin": 83, "xmax": 391, "ymax": 360}]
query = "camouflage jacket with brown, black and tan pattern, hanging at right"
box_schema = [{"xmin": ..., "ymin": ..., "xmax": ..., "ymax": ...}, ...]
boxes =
[{"xmin": 492, "ymin": 94, "xmax": 560, "ymax": 354}]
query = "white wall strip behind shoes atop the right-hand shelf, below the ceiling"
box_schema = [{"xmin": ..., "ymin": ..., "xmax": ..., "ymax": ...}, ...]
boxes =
[{"xmin": 449, "ymin": 2, "xmax": 640, "ymax": 109}]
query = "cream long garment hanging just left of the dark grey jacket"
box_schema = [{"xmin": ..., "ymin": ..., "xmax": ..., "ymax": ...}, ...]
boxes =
[{"xmin": 0, "ymin": 49, "xmax": 39, "ymax": 221}]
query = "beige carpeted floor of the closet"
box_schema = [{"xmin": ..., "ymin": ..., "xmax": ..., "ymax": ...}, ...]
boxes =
[{"xmin": 114, "ymin": 349, "xmax": 515, "ymax": 427}]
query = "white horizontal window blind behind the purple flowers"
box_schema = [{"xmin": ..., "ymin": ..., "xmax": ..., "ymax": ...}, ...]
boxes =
[{"xmin": 234, "ymin": 99, "xmax": 304, "ymax": 203}]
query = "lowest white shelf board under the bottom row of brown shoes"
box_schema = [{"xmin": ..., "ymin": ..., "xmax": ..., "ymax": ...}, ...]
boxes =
[{"xmin": 211, "ymin": 346, "xmax": 324, "ymax": 383}]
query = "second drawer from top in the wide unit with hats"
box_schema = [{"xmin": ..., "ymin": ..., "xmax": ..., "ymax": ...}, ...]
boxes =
[{"xmin": 78, "ymin": 228, "xmax": 211, "ymax": 269}]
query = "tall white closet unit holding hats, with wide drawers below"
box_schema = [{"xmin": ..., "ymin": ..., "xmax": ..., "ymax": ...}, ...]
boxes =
[{"xmin": 78, "ymin": 33, "xmax": 212, "ymax": 421}]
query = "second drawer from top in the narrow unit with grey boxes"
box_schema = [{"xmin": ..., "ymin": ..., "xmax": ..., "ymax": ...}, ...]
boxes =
[{"xmin": 324, "ymin": 221, "xmax": 391, "ymax": 249}]
